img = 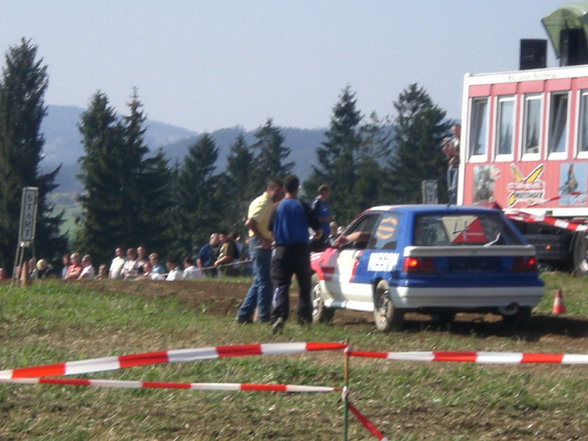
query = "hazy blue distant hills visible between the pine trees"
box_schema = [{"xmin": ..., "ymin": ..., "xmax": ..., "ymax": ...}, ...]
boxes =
[{"xmin": 41, "ymin": 106, "xmax": 326, "ymax": 193}]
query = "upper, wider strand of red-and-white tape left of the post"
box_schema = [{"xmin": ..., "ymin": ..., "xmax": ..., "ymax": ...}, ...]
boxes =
[{"xmin": 0, "ymin": 343, "xmax": 346, "ymax": 379}]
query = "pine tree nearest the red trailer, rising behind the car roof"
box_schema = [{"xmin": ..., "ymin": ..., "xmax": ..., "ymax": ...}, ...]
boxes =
[{"xmin": 387, "ymin": 84, "xmax": 450, "ymax": 203}]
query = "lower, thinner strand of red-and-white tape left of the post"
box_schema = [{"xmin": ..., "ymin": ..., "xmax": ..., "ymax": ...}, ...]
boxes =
[{"xmin": 0, "ymin": 378, "xmax": 341, "ymax": 393}]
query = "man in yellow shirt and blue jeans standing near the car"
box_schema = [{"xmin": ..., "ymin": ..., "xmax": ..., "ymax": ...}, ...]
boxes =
[{"xmin": 236, "ymin": 179, "xmax": 284, "ymax": 323}]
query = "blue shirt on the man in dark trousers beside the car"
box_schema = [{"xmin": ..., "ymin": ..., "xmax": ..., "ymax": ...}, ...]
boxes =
[{"xmin": 272, "ymin": 199, "xmax": 309, "ymax": 245}]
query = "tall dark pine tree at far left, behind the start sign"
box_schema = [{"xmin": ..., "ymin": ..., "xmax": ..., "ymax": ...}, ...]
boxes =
[{"xmin": 0, "ymin": 39, "xmax": 66, "ymax": 270}]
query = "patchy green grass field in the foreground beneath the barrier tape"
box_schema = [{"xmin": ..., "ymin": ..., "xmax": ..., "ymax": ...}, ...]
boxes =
[{"xmin": 0, "ymin": 274, "xmax": 588, "ymax": 441}]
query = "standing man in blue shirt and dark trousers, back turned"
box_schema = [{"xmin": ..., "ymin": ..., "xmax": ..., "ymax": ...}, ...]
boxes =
[{"xmin": 270, "ymin": 175, "xmax": 322, "ymax": 334}]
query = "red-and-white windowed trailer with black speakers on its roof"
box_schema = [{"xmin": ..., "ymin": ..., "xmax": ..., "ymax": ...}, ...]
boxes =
[{"xmin": 457, "ymin": 2, "xmax": 588, "ymax": 275}]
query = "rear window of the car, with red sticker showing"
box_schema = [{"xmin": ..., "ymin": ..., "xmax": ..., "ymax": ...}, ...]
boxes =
[{"xmin": 413, "ymin": 213, "xmax": 521, "ymax": 246}]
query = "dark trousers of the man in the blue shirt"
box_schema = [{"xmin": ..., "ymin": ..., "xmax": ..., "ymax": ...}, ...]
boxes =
[{"xmin": 271, "ymin": 243, "xmax": 312, "ymax": 324}]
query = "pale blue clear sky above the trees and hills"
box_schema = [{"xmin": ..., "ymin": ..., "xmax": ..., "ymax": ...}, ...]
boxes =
[{"xmin": 0, "ymin": 0, "xmax": 564, "ymax": 133}]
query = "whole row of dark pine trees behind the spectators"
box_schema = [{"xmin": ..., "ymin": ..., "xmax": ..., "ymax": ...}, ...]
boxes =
[{"xmin": 0, "ymin": 38, "xmax": 451, "ymax": 268}]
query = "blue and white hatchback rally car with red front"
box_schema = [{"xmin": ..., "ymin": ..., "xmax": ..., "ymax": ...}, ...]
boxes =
[{"xmin": 311, "ymin": 205, "xmax": 544, "ymax": 331}]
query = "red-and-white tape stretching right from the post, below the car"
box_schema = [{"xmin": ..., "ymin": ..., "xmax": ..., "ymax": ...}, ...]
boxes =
[{"xmin": 349, "ymin": 351, "xmax": 588, "ymax": 364}]
